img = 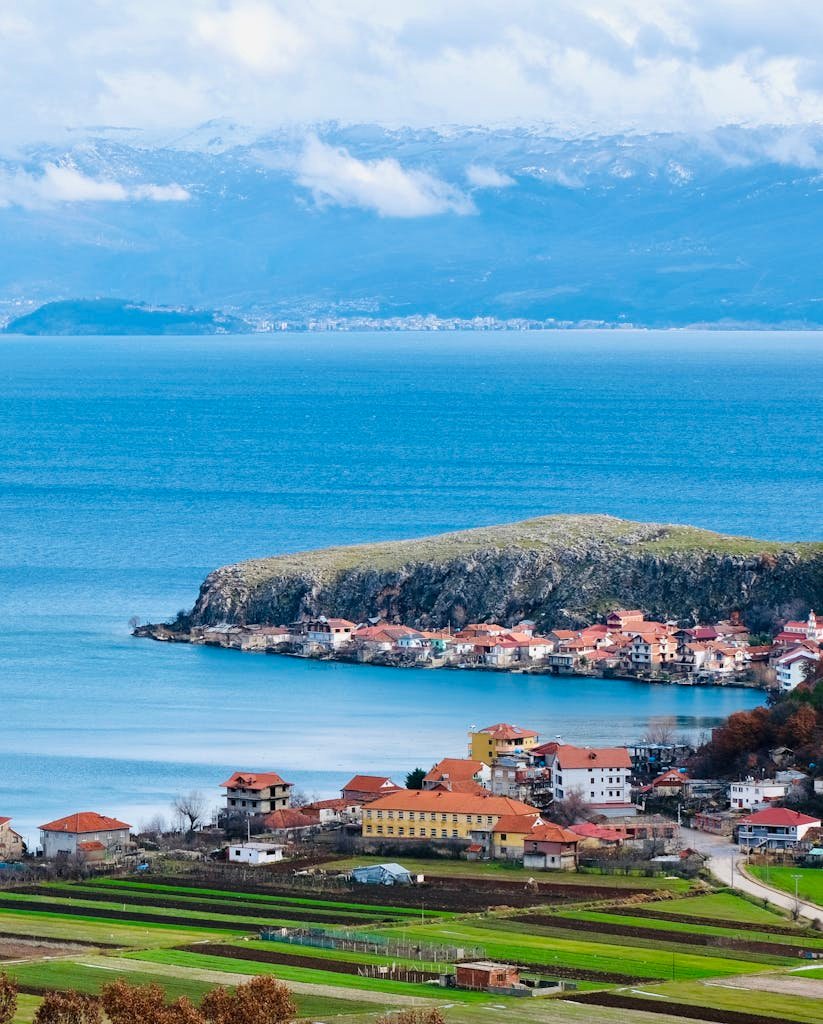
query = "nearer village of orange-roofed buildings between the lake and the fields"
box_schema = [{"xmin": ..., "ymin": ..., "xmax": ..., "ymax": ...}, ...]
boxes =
[{"xmin": 0, "ymin": 723, "xmax": 823, "ymax": 880}]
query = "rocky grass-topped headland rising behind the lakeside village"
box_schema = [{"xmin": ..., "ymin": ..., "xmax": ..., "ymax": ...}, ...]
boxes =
[{"xmin": 180, "ymin": 516, "xmax": 823, "ymax": 629}]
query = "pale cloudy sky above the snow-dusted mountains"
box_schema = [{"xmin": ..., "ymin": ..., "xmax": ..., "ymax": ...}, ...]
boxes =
[{"xmin": 0, "ymin": 0, "xmax": 823, "ymax": 148}]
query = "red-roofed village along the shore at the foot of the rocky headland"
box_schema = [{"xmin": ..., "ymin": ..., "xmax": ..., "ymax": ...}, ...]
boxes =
[{"xmin": 157, "ymin": 608, "xmax": 823, "ymax": 691}]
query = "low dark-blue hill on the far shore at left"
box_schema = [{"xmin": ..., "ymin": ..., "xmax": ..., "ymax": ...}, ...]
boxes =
[{"xmin": 4, "ymin": 299, "xmax": 250, "ymax": 335}]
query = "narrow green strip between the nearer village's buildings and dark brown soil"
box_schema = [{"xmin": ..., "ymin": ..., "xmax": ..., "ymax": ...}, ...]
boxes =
[{"xmin": 320, "ymin": 857, "xmax": 692, "ymax": 892}]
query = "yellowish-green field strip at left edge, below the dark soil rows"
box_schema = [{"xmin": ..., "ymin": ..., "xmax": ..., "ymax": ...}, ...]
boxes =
[{"xmin": 0, "ymin": 908, "xmax": 222, "ymax": 946}]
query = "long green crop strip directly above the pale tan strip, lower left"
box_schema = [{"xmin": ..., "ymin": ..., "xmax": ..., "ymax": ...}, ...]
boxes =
[{"xmin": 127, "ymin": 949, "xmax": 490, "ymax": 1001}]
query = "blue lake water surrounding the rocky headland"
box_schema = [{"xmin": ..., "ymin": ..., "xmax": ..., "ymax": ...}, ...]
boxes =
[{"xmin": 0, "ymin": 332, "xmax": 823, "ymax": 840}]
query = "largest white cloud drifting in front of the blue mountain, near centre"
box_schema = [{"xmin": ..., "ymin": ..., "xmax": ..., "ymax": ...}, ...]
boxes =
[{"xmin": 295, "ymin": 136, "xmax": 474, "ymax": 217}]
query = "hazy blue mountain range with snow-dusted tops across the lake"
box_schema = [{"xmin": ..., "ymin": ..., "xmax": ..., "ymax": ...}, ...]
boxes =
[{"xmin": 0, "ymin": 123, "xmax": 823, "ymax": 326}]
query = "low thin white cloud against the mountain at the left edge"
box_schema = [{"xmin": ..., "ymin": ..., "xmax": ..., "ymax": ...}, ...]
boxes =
[{"xmin": 0, "ymin": 164, "xmax": 190, "ymax": 209}]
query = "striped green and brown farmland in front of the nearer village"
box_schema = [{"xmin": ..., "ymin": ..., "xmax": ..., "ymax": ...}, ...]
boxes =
[{"xmin": 0, "ymin": 870, "xmax": 823, "ymax": 1024}]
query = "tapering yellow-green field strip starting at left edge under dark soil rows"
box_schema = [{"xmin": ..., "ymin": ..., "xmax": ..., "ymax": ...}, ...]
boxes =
[{"xmin": 0, "ymin": 906, "xmax": 239, "ymax": 946}]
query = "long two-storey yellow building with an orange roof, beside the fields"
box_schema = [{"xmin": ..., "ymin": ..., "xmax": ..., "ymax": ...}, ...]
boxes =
[{"xmin": 363, "ymin": 790, "xmax": 539, "ymax": 840}]
